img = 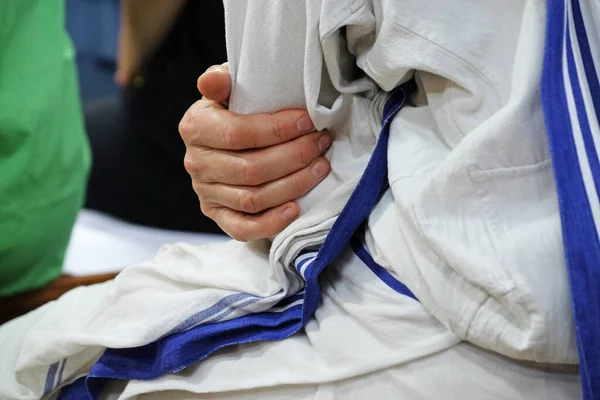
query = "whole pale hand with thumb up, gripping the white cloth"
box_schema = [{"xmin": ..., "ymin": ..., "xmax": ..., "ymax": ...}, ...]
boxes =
[{"xmin": 179, "ymin": 64, "xmax": 332, "ymax": 241}]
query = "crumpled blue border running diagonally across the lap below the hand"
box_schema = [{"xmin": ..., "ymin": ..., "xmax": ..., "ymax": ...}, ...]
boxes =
[{"xmin": 65, "ymin": 81, "xmax": 414, "ymax": 400}]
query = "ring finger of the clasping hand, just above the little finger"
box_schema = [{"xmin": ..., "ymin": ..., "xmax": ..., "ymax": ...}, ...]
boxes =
[{"xmin": 195, "ymin": 157, "xmax": 331, "ymax": 214}]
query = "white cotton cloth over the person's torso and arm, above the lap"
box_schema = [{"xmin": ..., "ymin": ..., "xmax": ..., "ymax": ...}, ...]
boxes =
[{"xmin": 226, "ymin": 0, "xmax": 577, "ymax": 363}]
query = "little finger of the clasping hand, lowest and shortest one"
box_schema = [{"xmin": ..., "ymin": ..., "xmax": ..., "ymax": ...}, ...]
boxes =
[{"xmin": 208, "ymin": 202, "xmax": 300, "ymax": 242}]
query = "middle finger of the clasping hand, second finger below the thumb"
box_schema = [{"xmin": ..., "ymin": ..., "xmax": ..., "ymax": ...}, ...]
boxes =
[{"xmin": 184, "ymin": 131, "xmax": 332, "ymax": 186}]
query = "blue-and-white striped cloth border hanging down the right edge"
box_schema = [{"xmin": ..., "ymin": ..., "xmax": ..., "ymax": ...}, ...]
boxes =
[{"xmin": 542, "ymin": 0, "xmax": 600, "ymax": 400}]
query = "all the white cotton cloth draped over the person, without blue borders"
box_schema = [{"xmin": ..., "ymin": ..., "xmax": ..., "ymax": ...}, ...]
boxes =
[{"xmin": 0, "ymin": 0, "xmax": 579, "ymax": 399}]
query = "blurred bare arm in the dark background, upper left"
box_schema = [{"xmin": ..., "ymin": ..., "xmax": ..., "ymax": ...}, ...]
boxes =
[{"xmin": 115, "ymin": 0, "xmax": 186, "ymax": 86}]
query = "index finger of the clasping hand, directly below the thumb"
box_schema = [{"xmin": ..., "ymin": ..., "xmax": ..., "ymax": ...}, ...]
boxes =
[{"xmin": 179, "ymin": 104, "xmax": 314, "ymax": 150}]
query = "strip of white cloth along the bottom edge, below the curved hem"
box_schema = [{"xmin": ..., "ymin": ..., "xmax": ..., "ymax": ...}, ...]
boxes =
[{"xmin": 105, "ymin": 334, "xmax": 581, "ymax": 400}]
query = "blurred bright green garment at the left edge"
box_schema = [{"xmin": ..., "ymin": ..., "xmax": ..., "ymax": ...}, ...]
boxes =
[{"xmin": 0, "ymin": 0, "xmax": 90, "ymax": 296}]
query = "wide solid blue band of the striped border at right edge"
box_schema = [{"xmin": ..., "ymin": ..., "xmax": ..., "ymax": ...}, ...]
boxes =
[{"xmin": 541, "ymin": 0, "xmax": 600, "ymax": 400}]
